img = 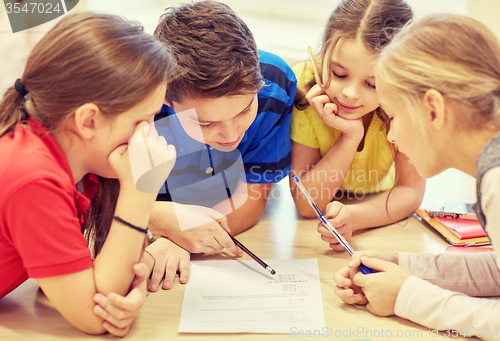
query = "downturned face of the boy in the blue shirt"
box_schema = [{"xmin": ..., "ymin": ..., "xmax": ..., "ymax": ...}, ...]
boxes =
[{"xmin": 172, "ymin": 93, "xmax": 258, "ymax": 152}]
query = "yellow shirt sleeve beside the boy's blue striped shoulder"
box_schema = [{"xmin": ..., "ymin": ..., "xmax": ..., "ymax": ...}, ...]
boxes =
[{"xmin": 290, "ymin": 61, "xmax": 319, "ymax": 148}]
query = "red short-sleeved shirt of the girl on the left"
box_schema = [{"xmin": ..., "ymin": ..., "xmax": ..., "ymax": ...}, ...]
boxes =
[{"xmin": 0, "ymin": 118, "xmax": 98, "ymax": 298}]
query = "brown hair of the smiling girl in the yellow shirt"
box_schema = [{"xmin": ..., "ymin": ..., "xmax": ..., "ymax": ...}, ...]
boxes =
[{"xmin": 294, "ymin": 0, "xmax": 413, "ymax": 110}]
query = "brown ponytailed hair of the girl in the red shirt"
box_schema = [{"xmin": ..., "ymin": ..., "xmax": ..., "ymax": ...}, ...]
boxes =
[{"xmin": 0, "ymin": 13, "xmax": 174, "ymax": 256}]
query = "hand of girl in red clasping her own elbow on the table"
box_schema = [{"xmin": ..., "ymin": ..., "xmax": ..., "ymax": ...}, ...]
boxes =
[{"xmin": 94, "ymin": 263, "xmax": 149, "ymax": 337}]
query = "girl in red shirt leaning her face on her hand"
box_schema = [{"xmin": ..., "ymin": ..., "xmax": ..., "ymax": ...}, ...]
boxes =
[{"xmin": 0, "ymin": 13, "xmax": 175, "ymax": 336}]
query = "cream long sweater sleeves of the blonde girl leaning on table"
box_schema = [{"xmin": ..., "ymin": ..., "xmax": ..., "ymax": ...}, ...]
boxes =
[{"xmin": 395, "ymin": 167, "xmax": 500, "ymax": 340}]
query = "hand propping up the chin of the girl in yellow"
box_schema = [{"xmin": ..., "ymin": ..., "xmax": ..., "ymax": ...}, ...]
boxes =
[{"xmin": 306, "ymin": 84, "xmax": 364, "ymax": 140}]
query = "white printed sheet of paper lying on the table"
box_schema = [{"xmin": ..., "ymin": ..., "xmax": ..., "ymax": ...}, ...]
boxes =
[{"xmin": 179, "ymin": 259, "xmax": 326, "ymax": 334}]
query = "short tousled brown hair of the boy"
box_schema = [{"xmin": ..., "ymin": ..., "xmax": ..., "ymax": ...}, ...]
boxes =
[{"xmin": 154, "ymin": 1, "xmax": 262, "ymax": 103}]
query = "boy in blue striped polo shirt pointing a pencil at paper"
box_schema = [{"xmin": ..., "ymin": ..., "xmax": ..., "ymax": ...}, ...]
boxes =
[{"xmin": 143, "ymin": 1, "xmax": 297, "ymax": 290}]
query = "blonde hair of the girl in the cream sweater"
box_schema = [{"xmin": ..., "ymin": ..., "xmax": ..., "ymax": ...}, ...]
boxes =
[{"xmin": 375, "ymin": 14, "xmax": 500, "ymax": 129}]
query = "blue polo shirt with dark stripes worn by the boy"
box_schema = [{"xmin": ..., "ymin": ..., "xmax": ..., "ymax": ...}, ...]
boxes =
[{"xmin": 155, "ymin": 51, "xmax": 297, "ymax": 207}]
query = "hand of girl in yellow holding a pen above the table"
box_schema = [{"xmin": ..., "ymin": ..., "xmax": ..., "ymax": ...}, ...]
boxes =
[{"xmin": 318, "ymin": 201, "xmax": 352, "ymax": 251}]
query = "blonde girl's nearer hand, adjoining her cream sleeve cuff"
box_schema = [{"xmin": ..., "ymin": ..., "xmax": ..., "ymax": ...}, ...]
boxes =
[{"xmin": 353, "ymin": 256, "xmax": 411, "ymax": 316}]
